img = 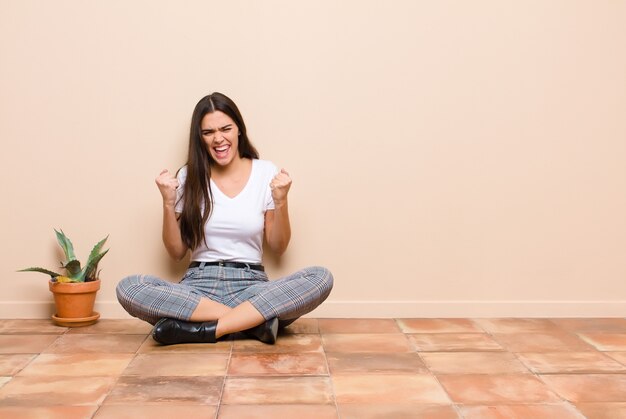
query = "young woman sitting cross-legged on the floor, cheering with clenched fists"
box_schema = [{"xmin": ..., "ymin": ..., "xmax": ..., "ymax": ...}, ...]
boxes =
[{"xmin": 117, "ymin": 93, "xmax": 333, "ymax": 344}]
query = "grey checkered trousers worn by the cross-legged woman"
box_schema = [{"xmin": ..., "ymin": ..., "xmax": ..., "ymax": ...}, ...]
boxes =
[{"xmin": 117, "ymin": 265, "xmax": 333, "ymax": 326}]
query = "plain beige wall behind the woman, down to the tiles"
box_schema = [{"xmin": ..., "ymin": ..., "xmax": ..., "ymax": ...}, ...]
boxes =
[{"xmin": 0, "ymin": 0, "xmax": 626, "ymax": 318}]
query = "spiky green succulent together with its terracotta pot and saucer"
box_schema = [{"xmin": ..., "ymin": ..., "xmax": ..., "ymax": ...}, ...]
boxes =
[{"xmin": 19, "ymin": 229, "xmax": 109, "ymax": 327}]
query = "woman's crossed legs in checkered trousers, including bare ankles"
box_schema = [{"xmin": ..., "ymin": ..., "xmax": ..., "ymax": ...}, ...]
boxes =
[{"xmin": 117, "ymin": 267, "xmax": 333, "ymax": 338}]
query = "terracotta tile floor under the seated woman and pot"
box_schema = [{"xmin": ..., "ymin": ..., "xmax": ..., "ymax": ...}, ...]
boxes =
[{"xmin": 0, "ymin": 318, "xmax": 626, "ymax": 419}]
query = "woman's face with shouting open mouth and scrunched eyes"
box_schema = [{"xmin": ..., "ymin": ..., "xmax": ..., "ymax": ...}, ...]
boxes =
[{"xmin": 200, "ymin": 111, "xmax": 239, "ymax": 167}]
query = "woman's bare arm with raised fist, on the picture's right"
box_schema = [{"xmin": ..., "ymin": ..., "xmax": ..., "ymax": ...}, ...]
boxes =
[{"xmin": 265, "ymin": 169, "xmax": 291, "ymax": 255}]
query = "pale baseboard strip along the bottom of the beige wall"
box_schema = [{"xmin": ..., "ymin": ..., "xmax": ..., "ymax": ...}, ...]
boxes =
[{"xmin": 0, "ymin": 301, "xmax": 626, "ymax": 319}]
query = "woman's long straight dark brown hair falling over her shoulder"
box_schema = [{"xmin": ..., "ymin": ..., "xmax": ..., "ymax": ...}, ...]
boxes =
[{"xmin": 180, "ymin": 92, "xmax": 259, "ymax": 249}]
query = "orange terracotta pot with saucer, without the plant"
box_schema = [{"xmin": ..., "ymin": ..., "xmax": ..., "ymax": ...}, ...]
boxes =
[{"xmin": 48, "ymin": 279, "xmax": 100, "ymax": 326}]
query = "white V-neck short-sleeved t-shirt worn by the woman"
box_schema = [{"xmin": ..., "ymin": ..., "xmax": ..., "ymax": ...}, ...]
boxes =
[{"xmin": 176, "ymin": 159, "xmax": 278, "ymax": 264}]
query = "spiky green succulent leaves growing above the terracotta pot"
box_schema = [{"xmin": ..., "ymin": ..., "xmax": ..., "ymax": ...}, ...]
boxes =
[{"xmin": 18, "ymin": 229, "xmax": 109, "ymax": 282}]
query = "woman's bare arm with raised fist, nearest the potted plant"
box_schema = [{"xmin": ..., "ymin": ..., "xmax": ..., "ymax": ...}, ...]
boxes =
[{"xmin": 155, "ymin": 170, "xmax": 187, "ymax": 261}]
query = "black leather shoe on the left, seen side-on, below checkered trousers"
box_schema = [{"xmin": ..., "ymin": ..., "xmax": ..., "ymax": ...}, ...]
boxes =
[{"xmin": 152, "ymin": 318, "xmax": 217, "ymax": 345}]
